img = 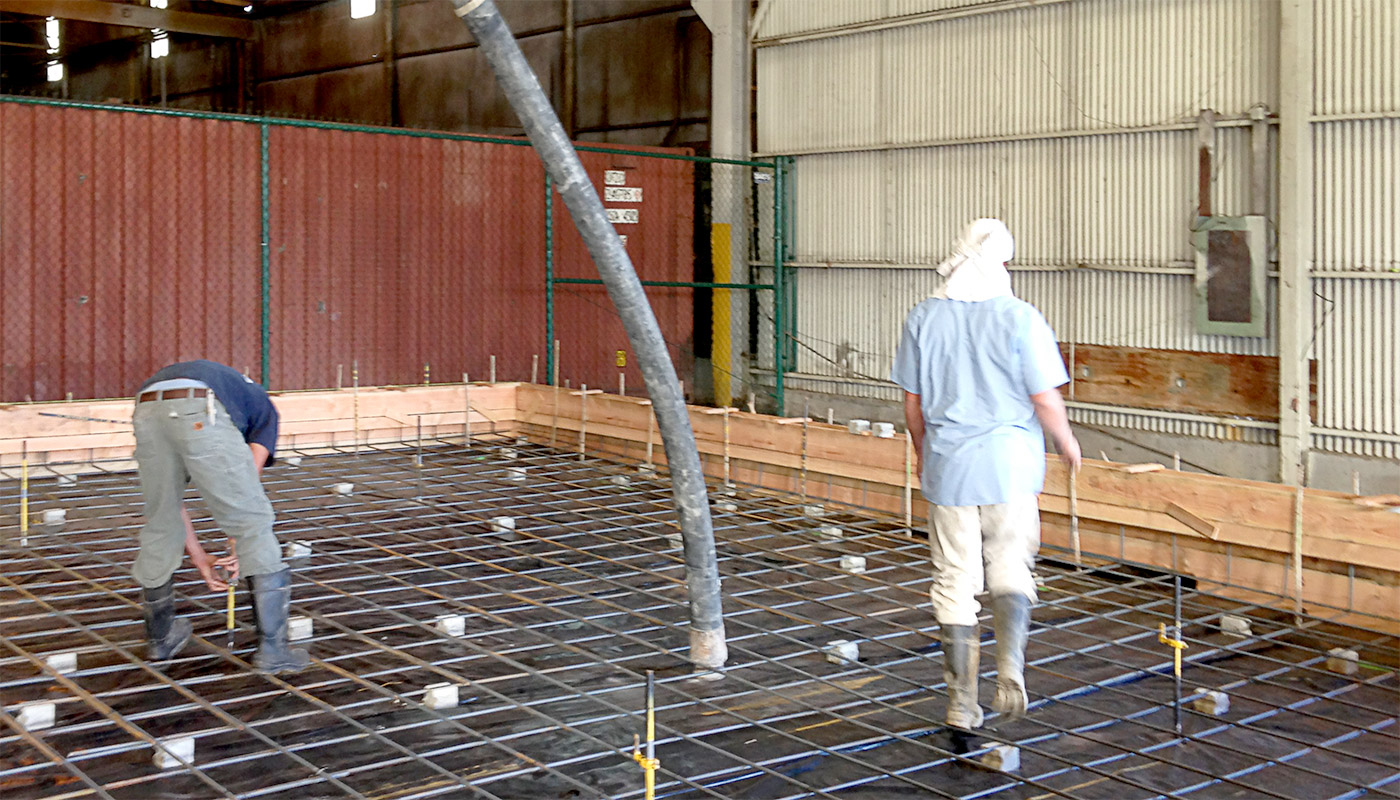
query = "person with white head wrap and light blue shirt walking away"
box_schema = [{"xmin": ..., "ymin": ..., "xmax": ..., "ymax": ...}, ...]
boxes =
[{"xmin": 890, "ymin": 219, "xmax": 1081, "ymax": 730}]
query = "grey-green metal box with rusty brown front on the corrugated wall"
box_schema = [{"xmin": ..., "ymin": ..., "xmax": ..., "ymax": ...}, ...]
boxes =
[{"xmin": 1191, "ymin": 216, "xmax": 1268, "ymax": 336}]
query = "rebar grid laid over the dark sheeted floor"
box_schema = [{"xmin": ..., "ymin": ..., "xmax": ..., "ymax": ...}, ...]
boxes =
[{"xmin": 0, "ymin": 436, "xmax": 1400, "ymax": 799}]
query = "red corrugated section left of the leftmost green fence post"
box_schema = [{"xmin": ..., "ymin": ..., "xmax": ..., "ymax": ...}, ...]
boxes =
[{"xmin": 0, "ymin": 104, "xmax": 260, "ymax": 401}]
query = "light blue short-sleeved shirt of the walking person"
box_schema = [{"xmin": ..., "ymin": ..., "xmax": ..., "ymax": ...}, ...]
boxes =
[{"xmin": 889, "ymin": 297, "xmax": 1070, "ymax": 506}]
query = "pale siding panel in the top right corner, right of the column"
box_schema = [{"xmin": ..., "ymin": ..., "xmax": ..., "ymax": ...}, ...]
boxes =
[{"xmin": 1313, "ymin": 0, "xmax": 1400, "ymax": 115}]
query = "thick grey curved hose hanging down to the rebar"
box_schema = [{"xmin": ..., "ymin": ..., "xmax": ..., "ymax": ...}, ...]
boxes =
[{"xmin": 452, "ymin": 0, "xmax": 728, "ymax": 670}]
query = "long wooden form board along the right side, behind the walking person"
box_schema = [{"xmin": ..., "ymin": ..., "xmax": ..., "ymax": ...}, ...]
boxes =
[{"xmin": 517, "ymin": 385, "xmax": 1400, "ymax": 628}]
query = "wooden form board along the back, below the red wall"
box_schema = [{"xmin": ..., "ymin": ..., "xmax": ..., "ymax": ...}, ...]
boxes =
[{"xmin": 0, "ymin": 384, "xmax": 515, "ymax": 476}]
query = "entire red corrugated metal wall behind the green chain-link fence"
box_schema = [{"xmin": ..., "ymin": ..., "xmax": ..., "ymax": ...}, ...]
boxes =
[{"xmin": 0, "ymin": 102, "xmax": 694, "ymax": 401}]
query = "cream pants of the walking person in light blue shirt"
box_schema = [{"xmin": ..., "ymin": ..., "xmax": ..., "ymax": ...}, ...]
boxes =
[{"xmin": 928, "ymin": 495, "xmax": 1040, "ymax": 625}]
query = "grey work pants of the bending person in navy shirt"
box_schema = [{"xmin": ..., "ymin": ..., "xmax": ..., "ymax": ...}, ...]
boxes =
[{"xmin": 132, "ymin": 398, "xmax": 283, "ymax": 588}]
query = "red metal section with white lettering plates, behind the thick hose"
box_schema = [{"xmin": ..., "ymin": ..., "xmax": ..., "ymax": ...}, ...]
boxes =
[{"xmin": 554, "ymin": 147, "xmax": 694, "ymax": 394}]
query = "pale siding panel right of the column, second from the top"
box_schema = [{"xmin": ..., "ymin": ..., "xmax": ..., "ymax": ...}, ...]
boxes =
[{"xmin": 1313, "ymin": 120, "xmax": 1400, "ymax": 272}]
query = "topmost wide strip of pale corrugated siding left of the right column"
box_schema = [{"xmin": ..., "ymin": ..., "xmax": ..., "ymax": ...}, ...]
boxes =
[{"xmin": 757, "ymin": 0, "xmax": 1278, "ymax": 153}]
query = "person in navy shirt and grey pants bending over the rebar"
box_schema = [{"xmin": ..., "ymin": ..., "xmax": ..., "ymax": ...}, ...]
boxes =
[{"xmin": 133, "ymin": 361, "xmax": 308, "ymax": 673}]
